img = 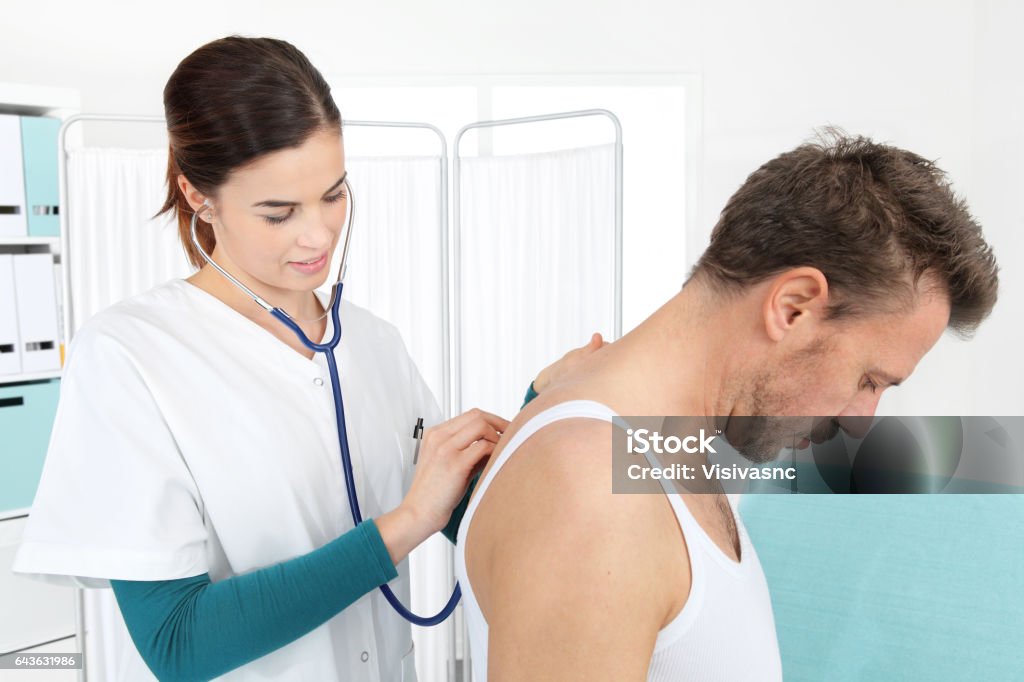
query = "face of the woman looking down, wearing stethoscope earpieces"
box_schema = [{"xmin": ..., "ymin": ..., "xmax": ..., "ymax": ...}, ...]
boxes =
[{"xmin": 205, "ymin": 130, "xmax": 349, "ymax": 291}]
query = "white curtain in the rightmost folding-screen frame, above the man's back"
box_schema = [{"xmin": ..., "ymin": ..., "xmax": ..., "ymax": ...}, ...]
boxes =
[{"xmin": 461, "ymin": 144, "xmax": 614, "ymax": 417}]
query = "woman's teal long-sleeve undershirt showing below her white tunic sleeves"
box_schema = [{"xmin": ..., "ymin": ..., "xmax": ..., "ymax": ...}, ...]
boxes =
[{"xmin": 111, "ymin": 384, "xmax": 537, "ymax": 681}]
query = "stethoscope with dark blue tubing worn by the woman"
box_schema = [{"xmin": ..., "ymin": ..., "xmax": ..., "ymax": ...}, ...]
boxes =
[{"xmin": 191, "ymin": 177, "xmax": 462, "ymax": 626}]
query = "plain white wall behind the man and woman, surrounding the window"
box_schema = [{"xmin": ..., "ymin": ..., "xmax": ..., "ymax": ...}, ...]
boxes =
[{"xmin": 0, "ymin": 0, "xmax": 1024, "ymax": 414}]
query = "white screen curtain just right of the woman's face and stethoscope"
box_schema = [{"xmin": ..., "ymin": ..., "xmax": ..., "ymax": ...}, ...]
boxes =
[{"xmin": 342, "ymin": 153, "xmax": 452, "ymax": 682}]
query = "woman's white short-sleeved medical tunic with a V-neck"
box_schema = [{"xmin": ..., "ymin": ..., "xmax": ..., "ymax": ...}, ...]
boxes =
[{"xmin": 14, "ymin": 280, "xmax": 441, "ymax": 682}]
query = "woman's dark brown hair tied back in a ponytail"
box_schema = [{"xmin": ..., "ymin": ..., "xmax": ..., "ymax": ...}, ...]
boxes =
[{"xmin": 157, "ymin": 36, "xmax": 341, "ymax": 267}]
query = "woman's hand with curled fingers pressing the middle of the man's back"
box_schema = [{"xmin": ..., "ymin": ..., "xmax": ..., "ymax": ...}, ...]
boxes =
[{"xmin": 376, "ymin": 409, "xmax": 509, "ymax": 564}]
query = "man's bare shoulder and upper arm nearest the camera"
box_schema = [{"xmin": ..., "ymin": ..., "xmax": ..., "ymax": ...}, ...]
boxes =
[{"xmin": 466, "ymin": 419, "xmax": 689, "ymax": 679}]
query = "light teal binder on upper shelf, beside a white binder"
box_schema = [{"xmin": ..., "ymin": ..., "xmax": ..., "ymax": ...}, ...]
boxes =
[{"xmin": 22, "ymin": 116, "xmax": 60, "ymax": 237}]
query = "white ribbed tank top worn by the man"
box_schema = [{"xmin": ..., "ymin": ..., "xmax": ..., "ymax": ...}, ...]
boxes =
[{"xmin": 455, "ymin": 400, "xmax": 782, "ymax": 682}]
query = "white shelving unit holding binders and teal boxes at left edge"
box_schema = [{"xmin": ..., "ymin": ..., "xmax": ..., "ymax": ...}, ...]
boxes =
[{"xmin": 0, "ymin": 83, "xmax": 82, "ymax": 682}]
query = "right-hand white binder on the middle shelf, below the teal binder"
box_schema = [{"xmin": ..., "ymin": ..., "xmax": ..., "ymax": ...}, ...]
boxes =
[{"xmin": 14, "ymin": 253, "xmax": 60, "ymax": 373}]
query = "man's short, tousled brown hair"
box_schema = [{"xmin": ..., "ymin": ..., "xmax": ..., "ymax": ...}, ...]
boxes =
[{"xmin": 690, "ymin": 128, "xmax": 998, "ymax": 338}]
